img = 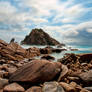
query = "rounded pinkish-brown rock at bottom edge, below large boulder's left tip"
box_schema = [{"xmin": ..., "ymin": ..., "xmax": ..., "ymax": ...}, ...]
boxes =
[{"xmin": 4, "ymin": 83, "xmax": 25, "ymax": 92}]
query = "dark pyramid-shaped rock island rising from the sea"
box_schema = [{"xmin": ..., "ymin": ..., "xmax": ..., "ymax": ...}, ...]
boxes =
[{"xmin": 21, "ymin": 29, "xmax": 60, "ymax": 45}]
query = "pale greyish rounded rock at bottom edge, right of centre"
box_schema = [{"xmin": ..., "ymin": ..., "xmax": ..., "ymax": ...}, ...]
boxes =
[{"xmin": 42, "ymin": 81, "xmax": 65, "ymax": 92}]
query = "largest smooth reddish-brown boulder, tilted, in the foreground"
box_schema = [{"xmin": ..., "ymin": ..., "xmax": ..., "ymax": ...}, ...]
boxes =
[{"xmin": 10, "ymin": 60, "xmax": 62, "ymax": 84}]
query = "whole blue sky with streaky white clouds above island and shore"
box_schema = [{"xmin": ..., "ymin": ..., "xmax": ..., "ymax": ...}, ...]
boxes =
[{"xmin": 0, "ymin": 0, "xmax": 92, "ymax": 45}]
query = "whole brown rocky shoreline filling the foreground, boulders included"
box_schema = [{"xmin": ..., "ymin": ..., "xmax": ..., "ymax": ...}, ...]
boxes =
[{"xmin": 0, "ymin": 40, "xmax": 92, "ymax": 92}]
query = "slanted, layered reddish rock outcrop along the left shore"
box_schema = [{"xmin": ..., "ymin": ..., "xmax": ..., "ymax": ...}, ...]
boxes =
[{"xmin": 0, "ymin": 40, "xmax": 40, "ymax": 61}]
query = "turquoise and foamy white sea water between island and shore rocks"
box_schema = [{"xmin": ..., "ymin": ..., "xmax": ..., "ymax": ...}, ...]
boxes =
[{"xmin": 22, "ymin": 45, "xmax": 92, "ymax": 61}]
